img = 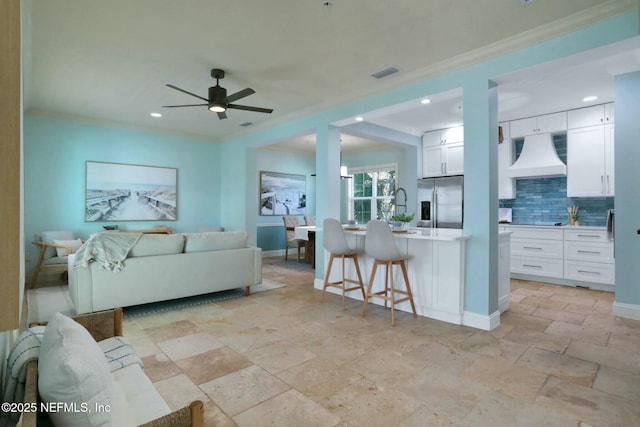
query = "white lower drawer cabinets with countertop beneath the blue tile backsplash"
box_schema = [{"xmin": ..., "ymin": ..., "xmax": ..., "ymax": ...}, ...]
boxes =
[{"xmin": 505, "ymin": 226, "xmax": 615, "ymax": 290}]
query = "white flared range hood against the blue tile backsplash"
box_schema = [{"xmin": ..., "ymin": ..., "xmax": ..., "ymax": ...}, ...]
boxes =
[{"xmin": 507, "ymin": 133, "xmax": 567, "ymax": 178}]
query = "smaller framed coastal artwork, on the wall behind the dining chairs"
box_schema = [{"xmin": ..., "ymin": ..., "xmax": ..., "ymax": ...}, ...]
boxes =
[{"xmin": 260, "ymin": 171, "xmax": 307, "ymax": 216}]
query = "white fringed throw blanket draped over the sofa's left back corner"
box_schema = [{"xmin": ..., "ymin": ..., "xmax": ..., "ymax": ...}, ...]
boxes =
[{"xmin": 73, "ymin": 233, "xmax": 142, "ymax": 271}]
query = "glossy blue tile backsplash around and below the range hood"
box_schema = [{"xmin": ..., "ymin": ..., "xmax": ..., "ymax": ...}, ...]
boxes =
[{"xmin": 499, "ymin": 135, "xmax": 614, "ymax": 226}]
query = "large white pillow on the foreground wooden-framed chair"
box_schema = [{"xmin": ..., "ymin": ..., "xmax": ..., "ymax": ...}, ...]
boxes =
[{"xmin": 38, "ymin": 313, "xmax": 113, "ymax": 427}]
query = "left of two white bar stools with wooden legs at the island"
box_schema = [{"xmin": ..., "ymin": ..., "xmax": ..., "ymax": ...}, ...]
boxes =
[{"xmin": 320, "ymin": 218, "xmax": 364, "ymax": 310}]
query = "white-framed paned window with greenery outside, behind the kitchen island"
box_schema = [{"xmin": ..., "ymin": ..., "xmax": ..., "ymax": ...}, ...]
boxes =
[{"xmin": 348, "ymin": 165, "xmax": 397, "ymax": 224}]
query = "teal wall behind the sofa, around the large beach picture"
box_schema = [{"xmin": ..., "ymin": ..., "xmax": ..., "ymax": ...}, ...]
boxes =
[{"xmin": 24, "ymin": 115, "xmax": 222, "ymax": 272}]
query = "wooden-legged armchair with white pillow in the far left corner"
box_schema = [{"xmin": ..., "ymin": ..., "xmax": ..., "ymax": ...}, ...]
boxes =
[{"xmin": 30, "ymin": 230, "xmax": 82, "ymax": 288}]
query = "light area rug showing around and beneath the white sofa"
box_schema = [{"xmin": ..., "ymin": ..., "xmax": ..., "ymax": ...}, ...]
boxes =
[{"xmin": 27, "ymin": 279, "xmax": 285, "ymax": 324}]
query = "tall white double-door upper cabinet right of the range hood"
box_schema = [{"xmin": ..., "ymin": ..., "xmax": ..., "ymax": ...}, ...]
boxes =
[{"xmin": 567, "ymin": 124, "xmax": 615, "ymax": 197}]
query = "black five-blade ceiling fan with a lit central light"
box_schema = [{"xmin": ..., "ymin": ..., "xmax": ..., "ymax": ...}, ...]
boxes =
[{"xmin": 163, "ymin": 68, "xmax": 273, "ymax": 120}]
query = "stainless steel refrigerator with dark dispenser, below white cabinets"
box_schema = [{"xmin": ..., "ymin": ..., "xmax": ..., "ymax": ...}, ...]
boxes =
[{"xmin": 417, "ymin": 175, "xmax": 464, "ymax": 228}]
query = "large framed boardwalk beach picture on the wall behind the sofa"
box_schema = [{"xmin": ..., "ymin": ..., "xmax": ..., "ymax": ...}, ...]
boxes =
[{"xmin": 85, "ymin": 161, "xmax": 178, "ymax": 222}]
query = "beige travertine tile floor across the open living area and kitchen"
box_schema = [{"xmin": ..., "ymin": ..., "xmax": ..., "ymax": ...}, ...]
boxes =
[{"xmin": 124, "ymin": 259, "xmax": 640, "ymax": 427}]
